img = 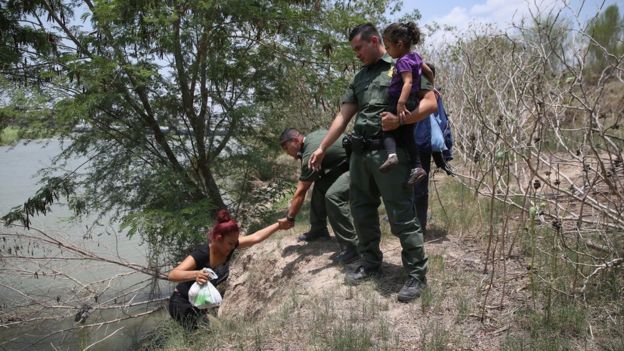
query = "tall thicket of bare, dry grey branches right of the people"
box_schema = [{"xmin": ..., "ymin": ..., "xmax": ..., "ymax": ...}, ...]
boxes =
[{"xmin": 428, "ymin": 2, "xmax": 624, "ymax": 344}]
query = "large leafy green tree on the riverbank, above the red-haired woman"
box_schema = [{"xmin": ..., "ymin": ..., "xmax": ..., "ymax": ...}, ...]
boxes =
[{"xmin": 3, "ymin": 0, "xmax": 408, "ymax": 262}]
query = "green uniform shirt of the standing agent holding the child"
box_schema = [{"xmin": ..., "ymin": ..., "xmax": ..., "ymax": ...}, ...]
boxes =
[{"xmin": 342, "ymin": 53, "xmax": 433, "ymax": 138}]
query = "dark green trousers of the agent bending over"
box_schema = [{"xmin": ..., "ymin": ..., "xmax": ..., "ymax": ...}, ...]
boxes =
[{"xmin": 310, "ymin": 172, "xmax": 357, "ymax": 249}]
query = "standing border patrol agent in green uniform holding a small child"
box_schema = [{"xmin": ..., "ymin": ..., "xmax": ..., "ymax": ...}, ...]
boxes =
[{"xmin": 310, "ymin": 23, "xmax": 437, "ymax": 302}]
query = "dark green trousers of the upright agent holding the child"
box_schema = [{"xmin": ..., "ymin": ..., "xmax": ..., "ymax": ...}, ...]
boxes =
[{"xmin": 350, "ymin": 148, "xmax": 427, "ymax": 281}]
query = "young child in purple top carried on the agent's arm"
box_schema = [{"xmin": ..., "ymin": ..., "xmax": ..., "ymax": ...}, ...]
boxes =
[{"xmin": 379, "ymin": 22, "xmax": 433, "ymax": 185}]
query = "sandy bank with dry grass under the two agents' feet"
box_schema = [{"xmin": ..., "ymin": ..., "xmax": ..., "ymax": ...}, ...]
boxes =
[{"xmin": 150, "ymin": 174, "xmax": 624, "ymax": 350}]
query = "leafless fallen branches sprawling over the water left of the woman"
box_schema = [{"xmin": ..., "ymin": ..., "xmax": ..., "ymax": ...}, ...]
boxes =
[{"xmin": 0, "ymin": 223, "xmax": 168, "ymax": 349}]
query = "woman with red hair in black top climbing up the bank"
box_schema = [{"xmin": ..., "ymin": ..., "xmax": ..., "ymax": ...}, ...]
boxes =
[{"xmin": 169, "ymin": 210, "xmax": 288, "ymax": 329}]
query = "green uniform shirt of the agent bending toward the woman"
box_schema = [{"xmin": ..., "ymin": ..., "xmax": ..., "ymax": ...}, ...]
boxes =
[{"xmin": 299, "ymin": 129, "xmax": 347, "ymax": 182}]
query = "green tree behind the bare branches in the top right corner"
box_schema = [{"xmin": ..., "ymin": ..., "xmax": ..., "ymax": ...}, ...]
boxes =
[{"xmin": 586, "ymin": 4, "xmax": 624, "ymax": 75}]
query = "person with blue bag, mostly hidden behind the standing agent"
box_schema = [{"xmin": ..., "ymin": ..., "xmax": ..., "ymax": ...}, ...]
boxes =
[{"xmin": 414, "ymin": 63, "xmax": 453, "ymax": 232}]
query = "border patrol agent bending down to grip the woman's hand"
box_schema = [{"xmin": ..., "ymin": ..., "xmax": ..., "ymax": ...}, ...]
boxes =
[{"xmin": 280, "ymin": 128, "xmax": 360, "ymax": 264}]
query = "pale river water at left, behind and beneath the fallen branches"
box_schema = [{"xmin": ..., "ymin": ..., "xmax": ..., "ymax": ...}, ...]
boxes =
[{"xmin": 0, "ymin": 140, "xmax": 171, "ymax": 350}]
